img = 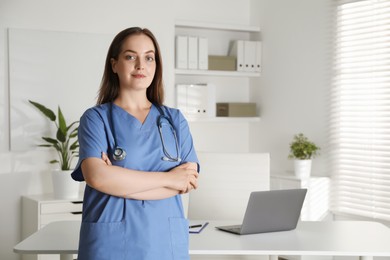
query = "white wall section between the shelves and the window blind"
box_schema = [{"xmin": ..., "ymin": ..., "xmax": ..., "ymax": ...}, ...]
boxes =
[{"xmin": 251, "ymin": 0, "xmax": 332, "ymax": 175}]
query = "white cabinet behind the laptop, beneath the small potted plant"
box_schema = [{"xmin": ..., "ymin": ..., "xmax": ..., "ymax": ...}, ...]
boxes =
[{"xmin": 271, "ymin": 175, "xmax": 330, "ymax": 221}]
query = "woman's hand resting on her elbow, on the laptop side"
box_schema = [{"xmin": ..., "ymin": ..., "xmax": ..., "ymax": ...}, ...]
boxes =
[{"xmin": 168, "ymin": 163, "xmax": 199, "ymax": 193}]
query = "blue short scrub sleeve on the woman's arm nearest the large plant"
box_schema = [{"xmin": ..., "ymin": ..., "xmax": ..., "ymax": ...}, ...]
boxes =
[{"xmin": 72, "ymin": 109, "xmax": 108, "ymax": 181}]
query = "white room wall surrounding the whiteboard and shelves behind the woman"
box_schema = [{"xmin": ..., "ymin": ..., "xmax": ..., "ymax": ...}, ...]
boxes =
[{"xmin": 0, "ymin": 0, "xmax": 330, "ymax": 260}]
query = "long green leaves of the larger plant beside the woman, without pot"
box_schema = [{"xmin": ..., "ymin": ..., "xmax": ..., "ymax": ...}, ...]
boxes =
[{"xmin": 29, "ymin": 100, "xmax": 79, "ymax": 171}]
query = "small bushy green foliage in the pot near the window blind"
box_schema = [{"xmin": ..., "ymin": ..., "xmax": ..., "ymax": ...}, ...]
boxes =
[{"xmin": 288, "ymin": 133, "xmax": 320, "ymax": 160}]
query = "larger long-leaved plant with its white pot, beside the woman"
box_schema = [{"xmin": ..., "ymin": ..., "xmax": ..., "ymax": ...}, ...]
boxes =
[{"xmin": 29, "ymin": 100, "xmax": 80, "ymax": 199}]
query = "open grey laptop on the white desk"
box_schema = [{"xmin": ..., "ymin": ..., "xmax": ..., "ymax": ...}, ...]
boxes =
[{"xmin": 216, "ymin": 189, "xmax": 307, "ymax": 235}]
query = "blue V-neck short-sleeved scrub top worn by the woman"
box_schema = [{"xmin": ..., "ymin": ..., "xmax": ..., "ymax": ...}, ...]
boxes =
[{"xmin": 72, "ymin": 103, "xmax": 198, "ymax": 260}]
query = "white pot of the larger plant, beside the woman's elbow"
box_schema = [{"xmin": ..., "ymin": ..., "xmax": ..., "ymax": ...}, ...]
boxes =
[{"xmin": 51, "ymin": 170, "xmax": 80, "ymax": 199}]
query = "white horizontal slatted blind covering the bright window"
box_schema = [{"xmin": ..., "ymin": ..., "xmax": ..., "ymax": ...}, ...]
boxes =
[{"xmin": 329, "ymin": 0, "xmax": 390, "ymax": 221}]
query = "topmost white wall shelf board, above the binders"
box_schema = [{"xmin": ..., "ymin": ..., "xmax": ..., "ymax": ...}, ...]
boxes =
[{"xmin": 175, "ymin": 20, "xmax": 260, "ymax": 32}]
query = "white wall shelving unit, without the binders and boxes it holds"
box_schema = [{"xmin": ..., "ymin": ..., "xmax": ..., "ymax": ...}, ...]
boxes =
[{"xmin": 175, "ymin": 20, "xmax": 260, "ymax": 123}]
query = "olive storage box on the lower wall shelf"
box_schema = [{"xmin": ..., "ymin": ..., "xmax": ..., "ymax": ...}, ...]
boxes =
[{"xmin": 217, "ymin": 103, "xmax": 256, "ymax": 117}]
